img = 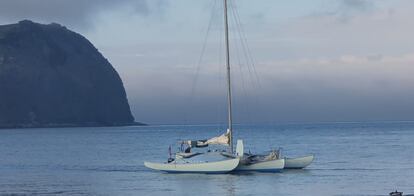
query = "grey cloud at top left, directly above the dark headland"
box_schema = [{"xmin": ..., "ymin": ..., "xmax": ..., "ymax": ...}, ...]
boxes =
[{"xmin": 0, "ymin": 0, "xmax": 167, "ymax": 28}]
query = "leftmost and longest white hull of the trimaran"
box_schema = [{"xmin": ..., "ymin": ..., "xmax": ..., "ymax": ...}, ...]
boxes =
[{"xmin": 144, "ymin": 158, "xmax": 240, "ymax": 174}]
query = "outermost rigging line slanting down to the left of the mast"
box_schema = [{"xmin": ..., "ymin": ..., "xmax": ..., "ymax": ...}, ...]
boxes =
[{"xmin": 186, "ymin": 0, "xmax": 217, "ymax": 124}]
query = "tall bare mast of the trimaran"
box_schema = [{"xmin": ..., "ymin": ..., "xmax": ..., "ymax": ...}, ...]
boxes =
[{"xmin": 224, "ymin": 0, "xmax": 233, "ymax": 153}]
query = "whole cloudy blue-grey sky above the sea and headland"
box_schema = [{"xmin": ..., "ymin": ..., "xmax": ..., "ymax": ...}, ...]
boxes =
[{"xmin": 0, "ymin": 0, "xmax": 414, "ymax": 124}]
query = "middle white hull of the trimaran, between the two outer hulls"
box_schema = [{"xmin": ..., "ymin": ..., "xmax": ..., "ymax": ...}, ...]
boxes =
[{"xmin": 234, "ymin": 159, "xmax": 285, "ymax": 172}]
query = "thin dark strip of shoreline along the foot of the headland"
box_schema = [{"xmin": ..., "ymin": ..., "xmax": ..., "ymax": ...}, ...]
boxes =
[{"xmin": 0, "ymin": 122, "xmax": 148, "ymax": 129}]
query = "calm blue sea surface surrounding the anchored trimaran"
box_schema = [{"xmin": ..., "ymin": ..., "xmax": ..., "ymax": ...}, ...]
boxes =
[{"xmin": 0, "ymin": 123, "xmax": 414, "ymax": 196}]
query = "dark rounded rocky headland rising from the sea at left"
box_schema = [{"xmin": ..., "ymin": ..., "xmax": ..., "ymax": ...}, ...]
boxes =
[{"xmin": 0, "ymin": 20, "xmax": 134, "ymax": 128}]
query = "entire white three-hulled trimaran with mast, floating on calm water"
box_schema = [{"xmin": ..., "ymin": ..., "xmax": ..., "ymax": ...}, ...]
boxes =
[{"xmin": 144, "ymin": 0, "xmax": 313, "ymax": 173}]
